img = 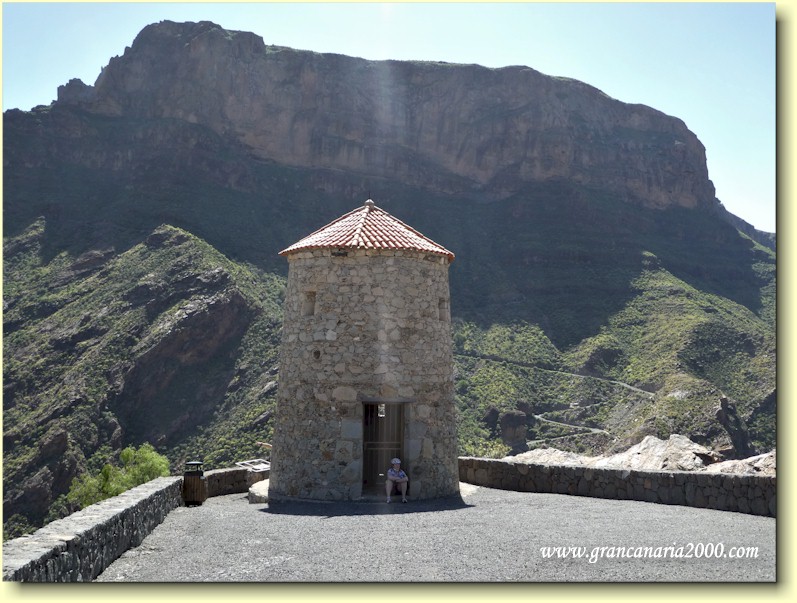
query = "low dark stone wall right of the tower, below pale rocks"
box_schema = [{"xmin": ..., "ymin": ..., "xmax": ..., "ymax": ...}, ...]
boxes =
[{"xmin": 459, "ymin": 457, "xmax": 777, "ymax": 517}]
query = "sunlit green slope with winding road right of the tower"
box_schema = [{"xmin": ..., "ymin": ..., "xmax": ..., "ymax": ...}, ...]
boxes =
[{"xmin": 454, "ymin": 252, "xmax": 775, "ymax": 453}]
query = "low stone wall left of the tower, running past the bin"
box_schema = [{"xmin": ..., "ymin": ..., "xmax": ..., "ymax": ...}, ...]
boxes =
[{"xmin": 3, "ymin": 467, "xmax": 268, "ymax": 582}]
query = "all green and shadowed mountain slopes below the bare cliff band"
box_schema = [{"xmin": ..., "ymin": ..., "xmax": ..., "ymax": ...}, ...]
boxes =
[{"xmin": 4, "ymin": 107, "xmax": 776, "ymax": 527}]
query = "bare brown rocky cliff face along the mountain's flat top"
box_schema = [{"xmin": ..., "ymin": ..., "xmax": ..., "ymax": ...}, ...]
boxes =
[{"xmin": 59, "ymin": 21, "xmax": 715, "ymax": 208}]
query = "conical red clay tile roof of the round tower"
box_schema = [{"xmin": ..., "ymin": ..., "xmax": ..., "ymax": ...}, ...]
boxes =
[{"xmin": 279, "ymin": 199, "xmax": 454, "ymax": 262}]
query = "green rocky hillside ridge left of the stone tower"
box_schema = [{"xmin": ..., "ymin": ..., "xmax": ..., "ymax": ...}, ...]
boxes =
[{"xmin": 3, "ymin": 221, "xmax": 284, "ymax": 536}]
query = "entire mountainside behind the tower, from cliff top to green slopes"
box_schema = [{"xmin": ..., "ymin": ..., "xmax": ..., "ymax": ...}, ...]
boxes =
[{"xmin": 3, "ymin": 22, "xmax": 776, "ymax": 536}]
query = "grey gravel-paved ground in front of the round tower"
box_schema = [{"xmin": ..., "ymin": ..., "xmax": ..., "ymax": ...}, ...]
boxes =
[{"xmin": 97, "ymin": 484, "xmax": 776, "ymax": 582}]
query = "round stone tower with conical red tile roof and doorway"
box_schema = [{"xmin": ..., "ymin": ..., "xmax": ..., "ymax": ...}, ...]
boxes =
[{"xmin": 269, "ymin": 199, "xmax": 459, "ymax": 500}]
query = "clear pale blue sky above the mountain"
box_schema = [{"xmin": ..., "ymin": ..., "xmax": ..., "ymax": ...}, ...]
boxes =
[{"xmin": 2, "ymin": 2, "xmax": 781, "ymax": 232}]
